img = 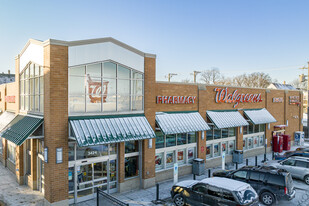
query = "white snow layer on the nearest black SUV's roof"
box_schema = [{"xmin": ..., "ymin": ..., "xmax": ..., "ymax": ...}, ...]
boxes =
[{"xmin": 201, "ymin": 177, "xmax": 248, "ymax": 191}]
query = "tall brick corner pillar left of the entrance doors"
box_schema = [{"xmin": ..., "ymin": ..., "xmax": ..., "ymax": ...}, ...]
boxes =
[{"xmin": 44, "ymin": 44, "xmax": 68, "ymax": 203}]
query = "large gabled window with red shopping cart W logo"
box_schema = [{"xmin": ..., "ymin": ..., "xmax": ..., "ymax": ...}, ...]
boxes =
[{"xmin": 69, "ymin": 62, "xmax": 144, "ymax": 113}]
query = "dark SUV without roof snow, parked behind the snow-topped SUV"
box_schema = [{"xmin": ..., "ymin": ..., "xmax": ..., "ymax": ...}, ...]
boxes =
[{"xmin": 213, "ymin": 166, "xmax": 295, "ymax": 205}]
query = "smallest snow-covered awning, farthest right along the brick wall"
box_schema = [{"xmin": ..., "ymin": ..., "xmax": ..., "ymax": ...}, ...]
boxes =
[{"xmin": 244, "ymin": 108, "xmax": 277, "ymax": 124}]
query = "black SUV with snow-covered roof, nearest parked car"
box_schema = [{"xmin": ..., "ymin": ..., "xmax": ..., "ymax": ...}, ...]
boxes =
[{"xmin": 171, "ymin": 177, "xmax": 258, "ymax": 206}]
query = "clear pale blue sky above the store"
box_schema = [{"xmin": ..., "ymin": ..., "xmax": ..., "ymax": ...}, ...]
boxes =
[{"xmin": 0, "ymin": 0, "xmax": 309, "ymax": 82}]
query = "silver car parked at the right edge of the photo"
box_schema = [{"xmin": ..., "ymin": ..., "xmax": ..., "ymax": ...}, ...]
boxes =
[{"xmin": 264, "ymin": 157, "xmax": 309, "ymax": 185}]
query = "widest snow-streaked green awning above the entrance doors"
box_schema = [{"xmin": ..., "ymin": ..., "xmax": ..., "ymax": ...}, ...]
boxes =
[{"xmin": 69, "ymin": 116, "xmax": 155, "ymax": 147}]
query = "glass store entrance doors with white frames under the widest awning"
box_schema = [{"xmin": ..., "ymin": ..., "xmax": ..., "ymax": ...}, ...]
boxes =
[{"xmin": 73, "ymin": 159, "xmax": 117, "ymax": 202}]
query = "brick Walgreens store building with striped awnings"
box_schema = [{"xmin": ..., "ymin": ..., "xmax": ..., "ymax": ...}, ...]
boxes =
[{"xmin": 0, "ymin": 38, "xmax": 302, "ymax": 205}]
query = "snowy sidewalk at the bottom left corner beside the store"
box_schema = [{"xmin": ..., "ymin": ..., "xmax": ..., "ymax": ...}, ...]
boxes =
[{"xmin": 0, "ymin": 163, "xmax": 44, "ymax": 206}]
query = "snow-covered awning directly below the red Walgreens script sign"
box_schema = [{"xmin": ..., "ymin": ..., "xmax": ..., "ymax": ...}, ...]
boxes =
[{"xmin": 206, "ymin": 111, "xmax": 249, "ymax": 129}]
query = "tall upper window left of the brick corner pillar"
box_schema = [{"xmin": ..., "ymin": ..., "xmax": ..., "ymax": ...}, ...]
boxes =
[{"xmin": 20, "ymin": 63, "xmax": 44, "ymax": 113}]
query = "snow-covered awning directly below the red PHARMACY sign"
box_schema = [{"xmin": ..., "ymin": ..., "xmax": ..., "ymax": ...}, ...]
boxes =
[{"xmin": 156, "ymin": 112, "xmax": 210, "ymax": 134}]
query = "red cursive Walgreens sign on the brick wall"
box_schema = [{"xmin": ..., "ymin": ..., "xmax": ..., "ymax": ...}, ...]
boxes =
[{"xmin": 215, "ymin": 88, "xmax": 262, "ymax": 108}]
